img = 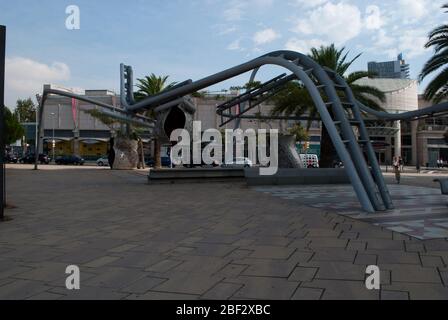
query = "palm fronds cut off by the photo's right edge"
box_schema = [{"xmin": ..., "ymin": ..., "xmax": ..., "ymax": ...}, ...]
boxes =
[{"xmin": 419, "ymin": 3, "xmax": 448, "ymax": 103}]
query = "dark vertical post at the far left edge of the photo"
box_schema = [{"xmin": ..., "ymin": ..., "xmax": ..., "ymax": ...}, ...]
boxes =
[{"xmin": 0, "ymin": 25, "xmax": 6, "ymax": 220}]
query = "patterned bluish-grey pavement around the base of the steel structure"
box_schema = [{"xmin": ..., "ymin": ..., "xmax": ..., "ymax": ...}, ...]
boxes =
[{"xmin": 255, "ymin": 184, "xmax": 448, "ymax": 240}]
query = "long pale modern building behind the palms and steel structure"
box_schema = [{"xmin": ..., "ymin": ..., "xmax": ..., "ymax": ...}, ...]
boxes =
[{"xmin": 35, "ymin": 78, "xmax": 448, "ymax": 166}]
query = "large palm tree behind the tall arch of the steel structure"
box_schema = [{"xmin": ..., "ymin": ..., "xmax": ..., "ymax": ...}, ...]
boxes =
[{"xmin": 272, "ymin": 44, "xmax": 386, "ymax": 167}]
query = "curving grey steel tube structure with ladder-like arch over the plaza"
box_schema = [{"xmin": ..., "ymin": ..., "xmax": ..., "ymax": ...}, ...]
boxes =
[{"xmin": 36, "ymin": 51, "xmax": 448, "ymax": 213}]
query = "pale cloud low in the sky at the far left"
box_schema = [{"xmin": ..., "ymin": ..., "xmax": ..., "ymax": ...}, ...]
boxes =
[{"xmin": 5, "ymin": 57, "xmax": 70, "ymax": 106}]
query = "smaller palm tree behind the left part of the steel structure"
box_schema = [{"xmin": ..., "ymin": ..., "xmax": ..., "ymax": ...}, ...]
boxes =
[{"xmin": 134, "ymin": 73, "xmax": 176, "ymax": 168}]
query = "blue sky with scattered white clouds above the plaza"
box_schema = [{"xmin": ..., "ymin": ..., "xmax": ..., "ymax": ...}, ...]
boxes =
[{"xmin": 0, "ymin": 0, "xmax": 448, "ymax": 107}]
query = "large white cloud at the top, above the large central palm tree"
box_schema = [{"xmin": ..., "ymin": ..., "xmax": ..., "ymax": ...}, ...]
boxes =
[{"xmin": 292, "ymin": 2, "xmax": 363, "ymax": 44}]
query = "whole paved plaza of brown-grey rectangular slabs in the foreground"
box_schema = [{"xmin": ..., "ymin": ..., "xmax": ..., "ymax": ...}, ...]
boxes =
[{"xmin": 0, "ymin": 165, "xmax": 448, "ymax": 300}]
